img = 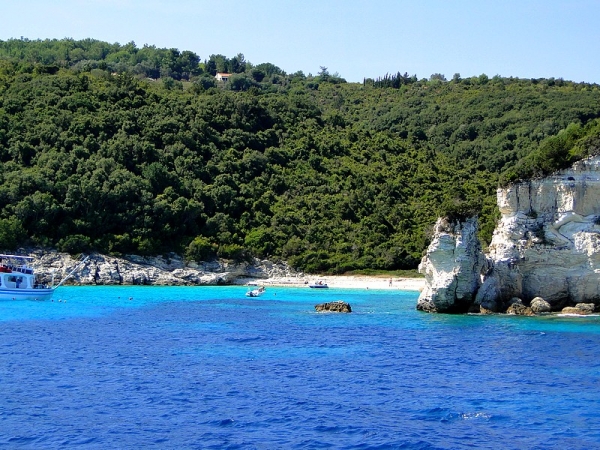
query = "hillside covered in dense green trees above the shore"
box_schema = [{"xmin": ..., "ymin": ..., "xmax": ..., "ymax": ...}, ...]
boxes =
[{"xmin": 0, "ymin": 39, "xmax": 600, "ymax": 273}]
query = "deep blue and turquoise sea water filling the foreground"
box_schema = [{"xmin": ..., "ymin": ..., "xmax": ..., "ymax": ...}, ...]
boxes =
[{"xmin": 0, "ymin": 287, "xmax": 600, "ymax": 449}]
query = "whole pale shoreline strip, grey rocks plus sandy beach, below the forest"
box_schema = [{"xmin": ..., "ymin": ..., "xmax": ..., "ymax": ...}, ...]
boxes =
[{"xmin": 25, "ymin": 249, "xmax": 425, "ymax": 291}]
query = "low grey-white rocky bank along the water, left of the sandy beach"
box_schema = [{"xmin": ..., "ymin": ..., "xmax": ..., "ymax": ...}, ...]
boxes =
[{"xmin": 31, "ymin": 251, "xmax": 298, "ymax": 286}]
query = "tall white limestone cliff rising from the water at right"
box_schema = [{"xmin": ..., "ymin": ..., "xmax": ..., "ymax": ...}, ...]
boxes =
[{"xmin": 419, "ymin": 156, "xmax": 600, "ymax": 311}]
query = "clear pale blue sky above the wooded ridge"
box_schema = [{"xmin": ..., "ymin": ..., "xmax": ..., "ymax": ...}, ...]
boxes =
[{"xmin": 0, "ymin": 0, "xmax": 600, "ymax": 83}]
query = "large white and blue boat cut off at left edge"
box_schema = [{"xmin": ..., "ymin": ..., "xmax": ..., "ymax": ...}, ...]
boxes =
[{"xmin": 0, "ymin": 255, "xmax": 88, "ymax": 300}]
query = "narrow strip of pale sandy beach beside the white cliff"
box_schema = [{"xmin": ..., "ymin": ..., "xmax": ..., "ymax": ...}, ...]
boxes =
[{"xmin": 238, "ymin": 275, "xmax": 425, "ymax": 291}]
